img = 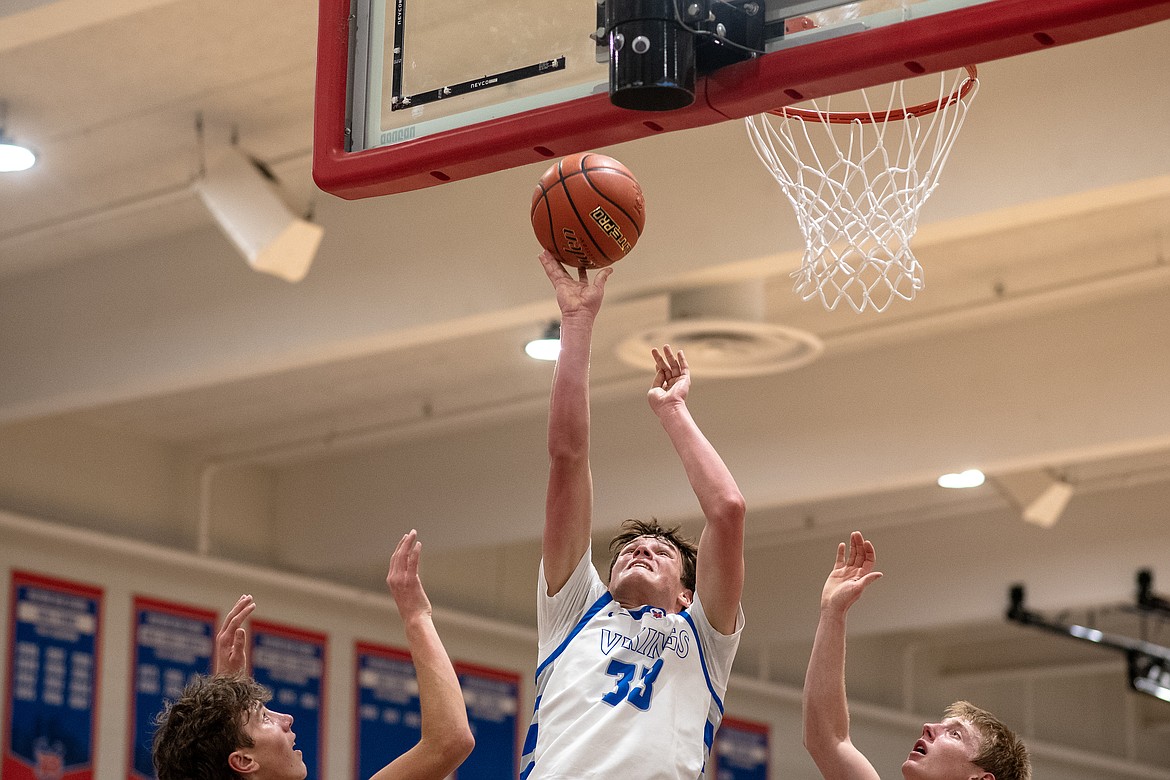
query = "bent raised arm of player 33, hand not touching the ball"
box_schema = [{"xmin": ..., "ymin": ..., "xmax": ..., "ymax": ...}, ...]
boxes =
[{"xmin": 647, "ymin": 345, "xmax": 744, "ymax": 634}]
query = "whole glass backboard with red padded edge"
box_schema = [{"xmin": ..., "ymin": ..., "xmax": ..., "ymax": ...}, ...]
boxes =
[{"xmin": 314, "ymin": 0, "xmax": 1170, "ymax": 199}]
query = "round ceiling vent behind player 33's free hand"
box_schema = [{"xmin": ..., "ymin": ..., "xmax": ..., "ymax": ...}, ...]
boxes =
[{"xmin": 617, "ymin": 319, "xmax": 825, "ymax": 377}]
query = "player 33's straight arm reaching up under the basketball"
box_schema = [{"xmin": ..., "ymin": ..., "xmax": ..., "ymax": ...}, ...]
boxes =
[{"xmin": 541, "ymin": 251, "xmax": 612, "ymax": 595}]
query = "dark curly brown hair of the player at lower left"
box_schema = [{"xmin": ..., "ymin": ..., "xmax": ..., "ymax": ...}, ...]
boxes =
[{"xmin": 152, "ymin": 675, "xmax": 270, "ymax": 780}]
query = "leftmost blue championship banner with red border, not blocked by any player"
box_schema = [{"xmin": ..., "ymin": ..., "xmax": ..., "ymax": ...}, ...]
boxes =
[{"xmin": 0, "ymin": 572, "xmax": 102, "ymax": 780}]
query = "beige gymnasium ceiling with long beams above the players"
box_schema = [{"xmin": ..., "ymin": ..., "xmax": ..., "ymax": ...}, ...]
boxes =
[{"xmin": 0, "ymin": 0, "xmax": 1170, "ymax": 776}]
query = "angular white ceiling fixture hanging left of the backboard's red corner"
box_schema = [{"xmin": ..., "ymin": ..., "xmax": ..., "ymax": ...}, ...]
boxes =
[{"xmin": 194, "ymin": 146, "xmax": 325, "ymax": 282}]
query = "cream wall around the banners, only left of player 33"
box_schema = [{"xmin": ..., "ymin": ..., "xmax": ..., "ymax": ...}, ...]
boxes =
[{"xmin": 0, "ymin": 512, "xmax": 536, "ymax": 780}]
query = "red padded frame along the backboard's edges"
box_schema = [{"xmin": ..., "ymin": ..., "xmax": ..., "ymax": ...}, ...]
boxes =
[{"xmin": 312, "ymin": 0, "xmax": 1170, "ymax": 200}]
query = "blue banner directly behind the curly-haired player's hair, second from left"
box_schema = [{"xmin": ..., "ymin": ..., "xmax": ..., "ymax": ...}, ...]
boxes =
[{"xmin": 129, "ymin": 596, "xmax": 216, "ymax": 780}]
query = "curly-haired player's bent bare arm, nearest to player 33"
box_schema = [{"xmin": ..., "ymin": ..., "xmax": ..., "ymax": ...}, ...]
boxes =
[{"xmin": 371, "ymin": 531, "xmax": 475, "ymax": 780}]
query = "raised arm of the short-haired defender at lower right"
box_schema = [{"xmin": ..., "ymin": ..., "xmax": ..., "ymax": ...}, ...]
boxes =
[{"xmin": 804, "ymin": 531, "xmax": 881, "ymax": 780}]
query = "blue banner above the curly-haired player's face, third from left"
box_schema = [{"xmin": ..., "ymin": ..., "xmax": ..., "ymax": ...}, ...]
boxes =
[{"xmin": 250, "ymin": 620, "xmax": 325, "ymax": 778}]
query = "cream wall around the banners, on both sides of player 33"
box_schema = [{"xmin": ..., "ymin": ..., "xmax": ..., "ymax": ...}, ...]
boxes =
[{"xmin": 0, "ymin": 512, "xmax": 1170, "ymax": 780}]
